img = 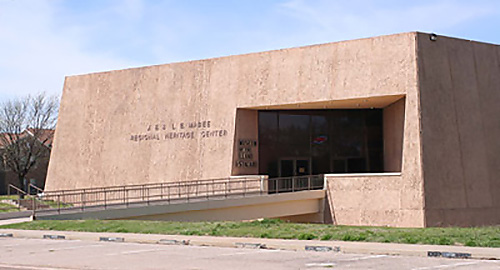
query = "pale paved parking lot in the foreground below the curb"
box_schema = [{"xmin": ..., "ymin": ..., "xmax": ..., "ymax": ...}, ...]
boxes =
[{"xmin": 0, "ymin": 238, "xmax": 500, "ymax": 270}]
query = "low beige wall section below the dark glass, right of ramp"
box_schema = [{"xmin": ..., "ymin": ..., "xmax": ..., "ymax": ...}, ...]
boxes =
[{"xmin": 327, "ymin": 173, "xmax": 424, "ymax": 227}]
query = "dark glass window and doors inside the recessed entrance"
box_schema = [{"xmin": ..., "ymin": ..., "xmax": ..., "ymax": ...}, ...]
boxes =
[{"xmin": 259, "ymin": 109, "xmax": 384, "ymax": 177}]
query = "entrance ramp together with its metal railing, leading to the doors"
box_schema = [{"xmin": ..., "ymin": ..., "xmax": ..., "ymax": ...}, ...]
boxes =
[{"xmin": 35, "ymin": 176, "xmax": 325, "ymax": 222}]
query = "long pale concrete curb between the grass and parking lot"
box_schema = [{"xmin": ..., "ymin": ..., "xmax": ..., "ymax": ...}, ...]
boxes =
[{"xmin": 0, "ymin": 229, "xmax": 500, "ymax": 260}]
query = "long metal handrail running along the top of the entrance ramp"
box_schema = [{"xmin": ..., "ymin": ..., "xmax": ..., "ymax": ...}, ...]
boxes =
[{"xmin": 33, "ymin": 175, "xmax": 323, "ymax": 213}]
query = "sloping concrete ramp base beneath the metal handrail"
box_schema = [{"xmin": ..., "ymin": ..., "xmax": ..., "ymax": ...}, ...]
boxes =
[{"xmin": 36, "ymin": 190, "xmax": 325, "ymax": 222}]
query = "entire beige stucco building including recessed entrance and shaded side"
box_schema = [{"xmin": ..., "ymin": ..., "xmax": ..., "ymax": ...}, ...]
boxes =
[{"xmin": 46, "ymin": 32, "xmax": 500, "ymax": 227}]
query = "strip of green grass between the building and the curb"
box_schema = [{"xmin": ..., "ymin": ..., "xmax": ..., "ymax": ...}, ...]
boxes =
[{"xmin": 0, "ymin": 219, "xmax": 500, "ymax": 247}]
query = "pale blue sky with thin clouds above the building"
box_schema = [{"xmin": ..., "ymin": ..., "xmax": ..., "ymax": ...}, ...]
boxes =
[{"xmin": 0, "ymin": 0, "xmax": 500, "ymax": 102}]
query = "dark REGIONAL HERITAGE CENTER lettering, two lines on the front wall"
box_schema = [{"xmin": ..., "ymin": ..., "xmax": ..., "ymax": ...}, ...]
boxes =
[{"xmin": 130, "ymin": 120, "xmax": 228, "ymax": 142}]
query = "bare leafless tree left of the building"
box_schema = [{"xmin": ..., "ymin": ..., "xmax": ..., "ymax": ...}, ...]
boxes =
[{"xmin": 0, "ymin": 93, "xmax": 59, "ymax": 192}]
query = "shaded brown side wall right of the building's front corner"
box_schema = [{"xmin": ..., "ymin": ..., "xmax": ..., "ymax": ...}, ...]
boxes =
[{"xmin": 418, "ymin": 34, "xmax": 500, "ymax": 226}]
